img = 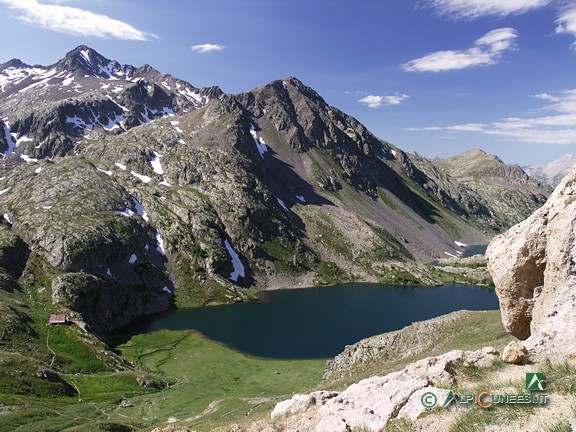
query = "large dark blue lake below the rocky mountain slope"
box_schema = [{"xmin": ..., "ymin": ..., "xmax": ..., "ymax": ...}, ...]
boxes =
[{"xmin": 113, "ymin": 283, "xmax": 498, "ymax": 359}]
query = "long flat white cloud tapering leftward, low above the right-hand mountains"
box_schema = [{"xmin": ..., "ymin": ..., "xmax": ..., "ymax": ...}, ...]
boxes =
[{"xmin": 407, "ymin": 89, "xmax": 576, "ymax": 144}]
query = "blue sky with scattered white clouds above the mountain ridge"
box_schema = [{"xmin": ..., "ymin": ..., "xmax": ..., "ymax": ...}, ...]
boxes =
[{"xmin": 0, "ymin": 0, "xmax": 576, "ymax": 164}]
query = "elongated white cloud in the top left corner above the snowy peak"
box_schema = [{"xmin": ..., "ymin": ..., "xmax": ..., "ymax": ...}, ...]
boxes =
[{"xmin": 0, "ymin": 0, "xmax": 158, "ymax": 41}]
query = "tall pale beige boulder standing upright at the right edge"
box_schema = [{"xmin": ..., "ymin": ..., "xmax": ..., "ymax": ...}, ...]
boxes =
[{"xmin": 487, "ymin": 164, "xmax": 576, "ymax": 363}]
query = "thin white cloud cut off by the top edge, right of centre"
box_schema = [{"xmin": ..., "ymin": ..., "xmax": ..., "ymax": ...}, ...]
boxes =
[{"xmin": 421, "ymin": 0, "xmax": 554, "ymax": 19}]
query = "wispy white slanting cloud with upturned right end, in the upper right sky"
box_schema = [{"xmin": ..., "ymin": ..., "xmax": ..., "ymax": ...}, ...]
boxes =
[{"xmin": 402, "ymin": 28, "xmax": 518, "ymax": 72}]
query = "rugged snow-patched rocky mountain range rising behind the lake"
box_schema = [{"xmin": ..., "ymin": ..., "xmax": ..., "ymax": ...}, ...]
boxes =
[{"xmin": 0, "ymin": 46, "xmax": 550, "ymax": 334}]
